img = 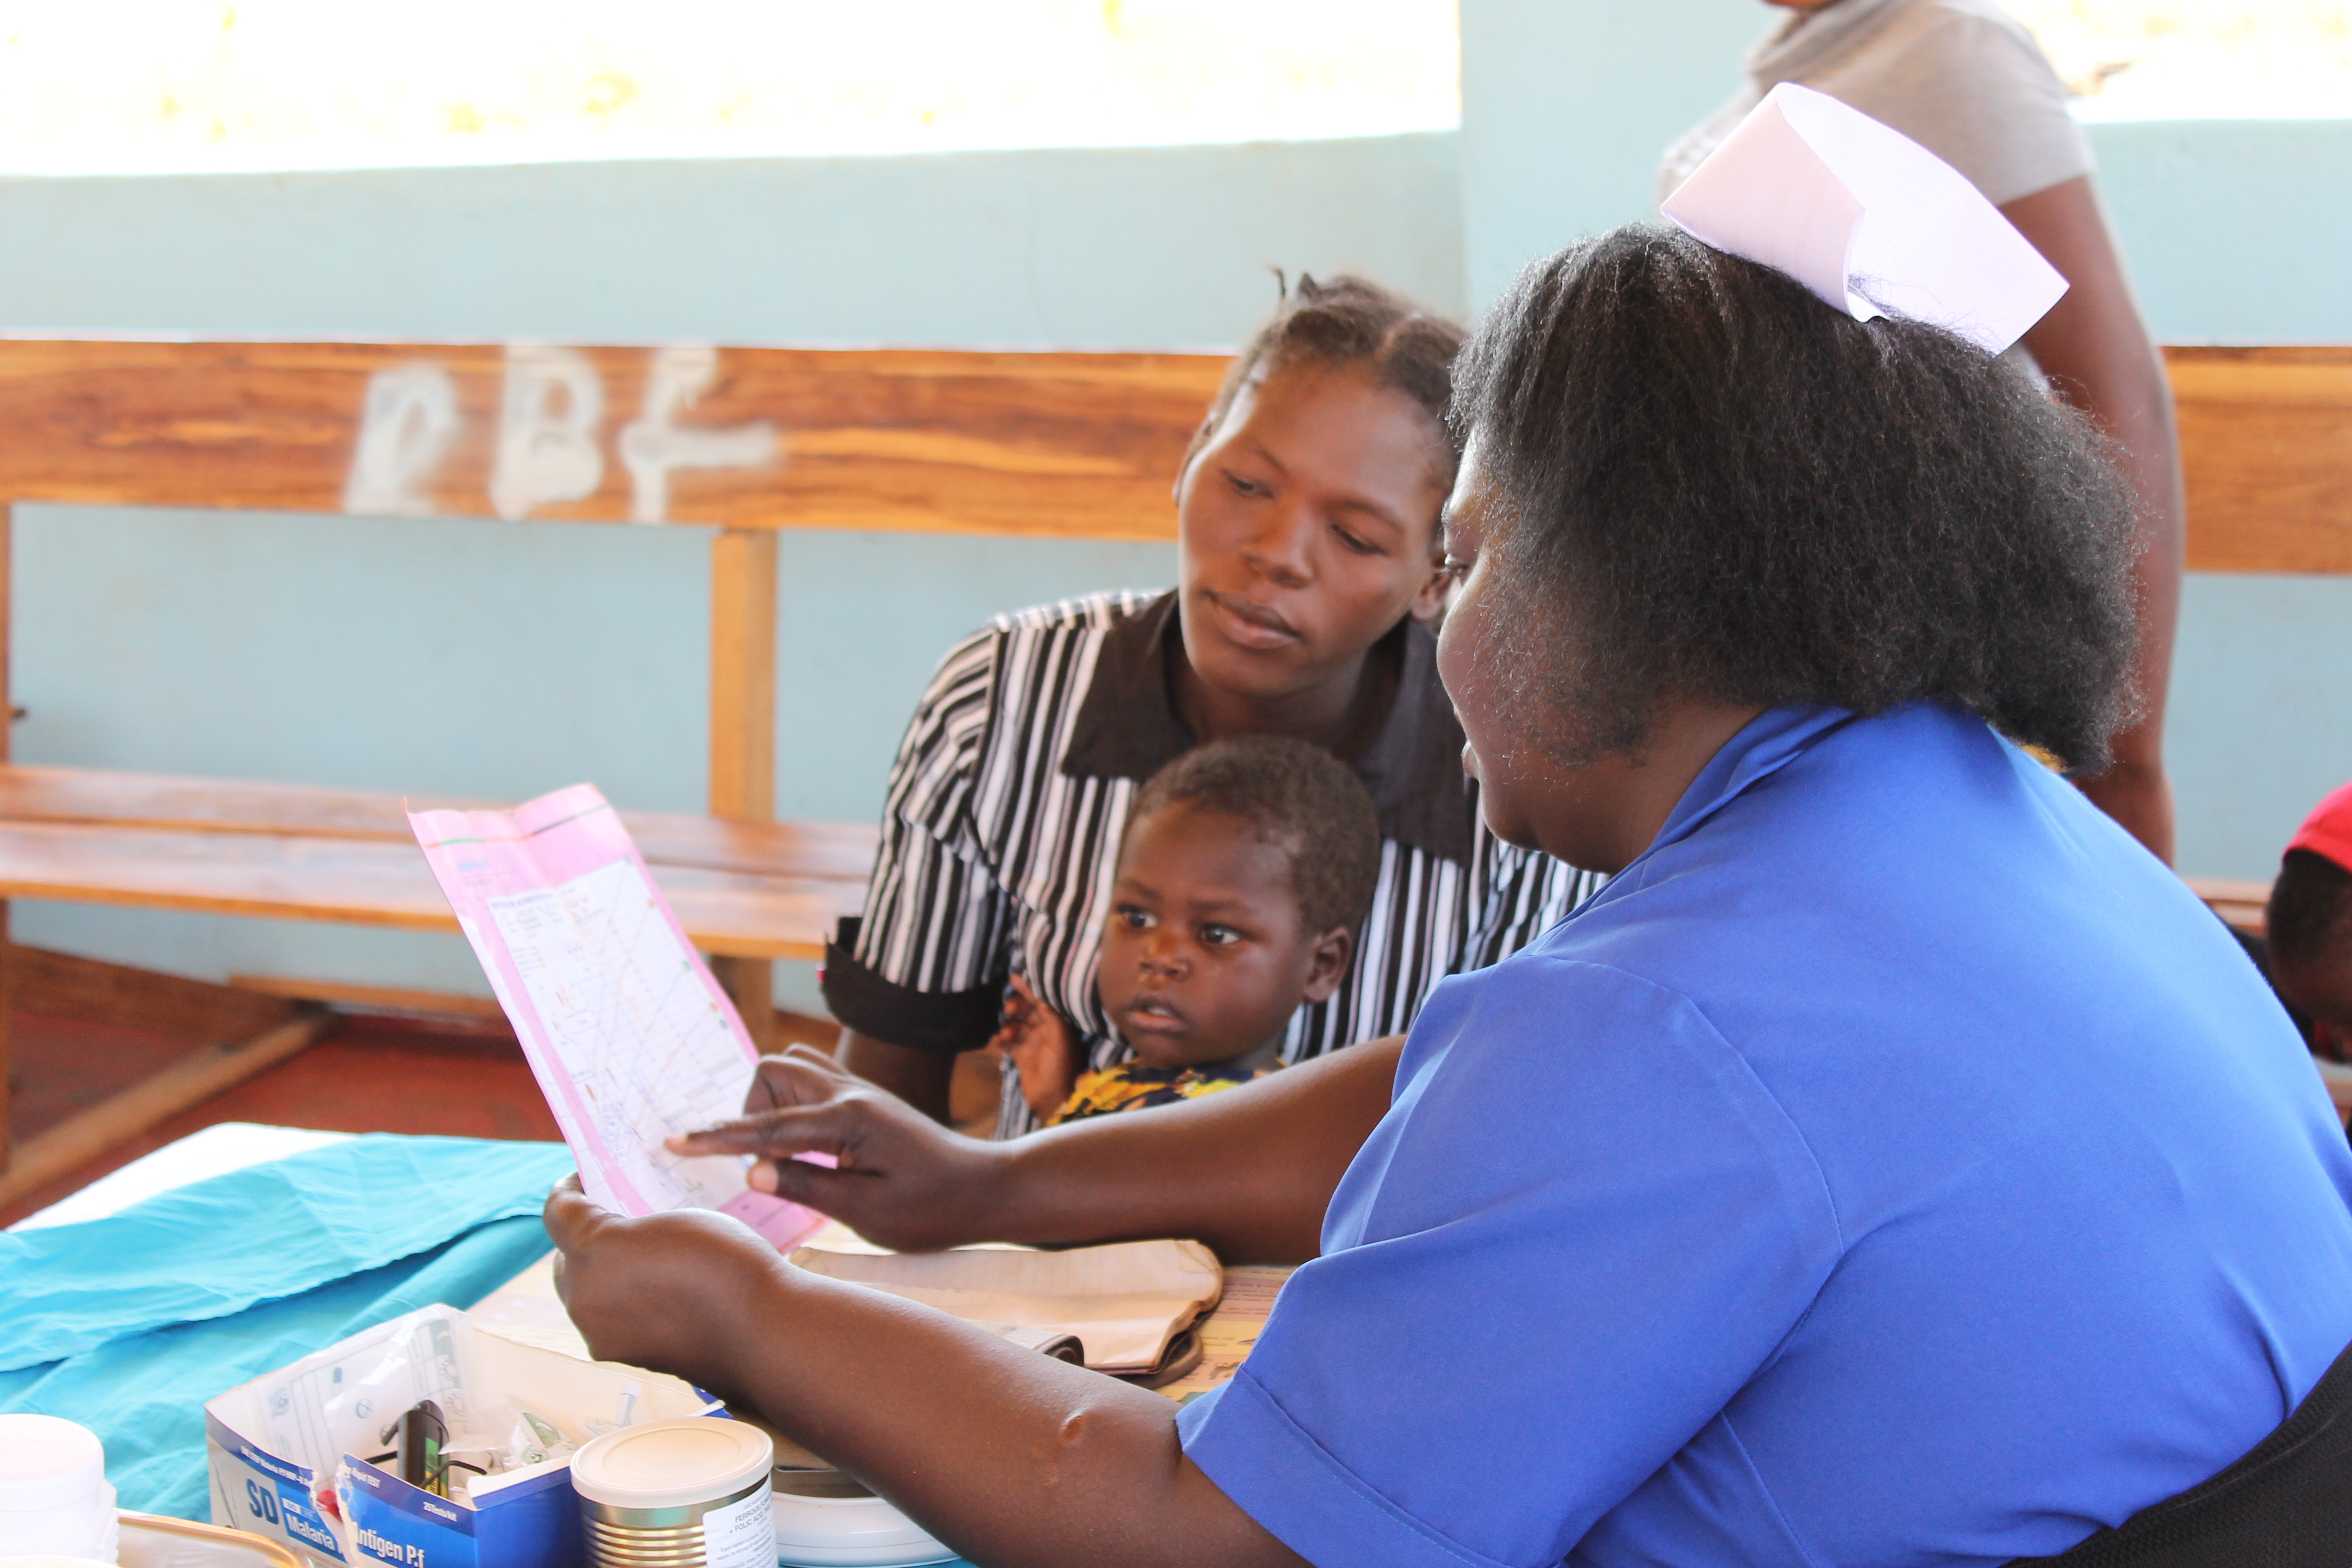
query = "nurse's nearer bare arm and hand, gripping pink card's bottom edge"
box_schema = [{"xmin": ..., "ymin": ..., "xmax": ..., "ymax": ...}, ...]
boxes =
[{"xmin": 546, "ymin": 1189, "xmax": 1303, "ymax": 1568}]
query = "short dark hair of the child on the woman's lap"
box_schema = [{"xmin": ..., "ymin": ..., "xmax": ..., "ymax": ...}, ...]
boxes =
[{"xmin": 1126, "ymin": 736, "xmax": 1381, "ymax": 931}]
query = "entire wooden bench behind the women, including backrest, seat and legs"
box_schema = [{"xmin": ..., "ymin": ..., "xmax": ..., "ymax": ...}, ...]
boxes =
[{"xmin": 0, "ymin": 339, "xmax": 2352, "ymax": 1201}]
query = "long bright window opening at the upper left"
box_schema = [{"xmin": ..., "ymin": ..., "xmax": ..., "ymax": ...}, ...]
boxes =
[{"xmin": 0, "ymin": 0, "xmax": 1461, "ymax": 174}]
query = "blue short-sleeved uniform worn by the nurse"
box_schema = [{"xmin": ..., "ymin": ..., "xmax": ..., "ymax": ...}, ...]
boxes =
[{"xmin": 1181, "ymin": 705, "xmax": 2352, "ymax": 1568}]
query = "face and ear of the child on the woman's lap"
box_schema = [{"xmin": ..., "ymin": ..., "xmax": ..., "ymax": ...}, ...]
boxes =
[{"xmin": 1093, "ymin": 802, "xmax": 1355, "ymax": 1068}]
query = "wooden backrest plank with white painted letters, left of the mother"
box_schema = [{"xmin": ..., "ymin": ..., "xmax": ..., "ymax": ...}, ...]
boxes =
[{"xmin": 0, "ymin": 339, "xmax": 1226, "ymax": 538}]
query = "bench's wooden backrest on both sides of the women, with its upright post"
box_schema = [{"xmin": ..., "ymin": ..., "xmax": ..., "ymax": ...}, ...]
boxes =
[{"xmin": 0, "ymin": 339, "xmax": 2352, "ymax": 820}]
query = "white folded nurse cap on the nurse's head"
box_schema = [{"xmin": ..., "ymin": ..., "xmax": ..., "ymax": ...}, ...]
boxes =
[{"xmin": 1660, "ymin": 82, "xmax": 2065, "ymax": 355}]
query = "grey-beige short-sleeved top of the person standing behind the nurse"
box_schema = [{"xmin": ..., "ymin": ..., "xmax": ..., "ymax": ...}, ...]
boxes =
[{"xmin": 1658, "ymin": 0, "xmax": 2091, "ymax": 207}]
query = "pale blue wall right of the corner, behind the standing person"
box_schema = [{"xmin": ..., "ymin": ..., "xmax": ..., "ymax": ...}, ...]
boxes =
[{"xmin": 1461, "ymin": 0, "xmax": 2352, "ymax": 877}]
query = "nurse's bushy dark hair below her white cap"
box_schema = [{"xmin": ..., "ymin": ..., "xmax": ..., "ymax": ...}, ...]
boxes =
[{"xmin": 1453, "ymin": 226, "xmax": 2136, "ymax": 774}]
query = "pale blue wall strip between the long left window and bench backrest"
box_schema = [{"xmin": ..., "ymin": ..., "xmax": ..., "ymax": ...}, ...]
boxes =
[{"xmin": 0, "ymin": 134, "xmax": 1463, "ymax": 348}]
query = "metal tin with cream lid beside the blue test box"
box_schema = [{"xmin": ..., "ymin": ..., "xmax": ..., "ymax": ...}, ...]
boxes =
[{"xmin": 571, "ymin": 1415, "xmax": 776, "ymax": 1568}]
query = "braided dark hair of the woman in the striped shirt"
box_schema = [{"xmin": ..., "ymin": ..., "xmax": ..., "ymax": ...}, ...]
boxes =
[{"xmin": 1185, "ymin": 275, "xmax": 1468, "ymax": 487}]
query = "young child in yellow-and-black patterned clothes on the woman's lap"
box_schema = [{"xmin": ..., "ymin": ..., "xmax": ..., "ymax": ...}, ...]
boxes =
[{"xmin": 995, "ymin": 736, "xmax": 1381, "ymax": 1126}]
